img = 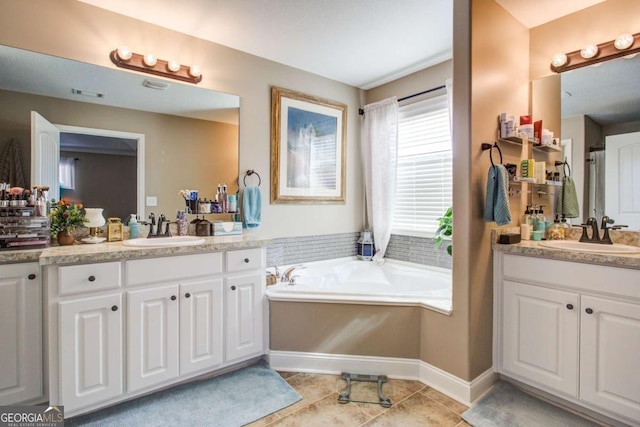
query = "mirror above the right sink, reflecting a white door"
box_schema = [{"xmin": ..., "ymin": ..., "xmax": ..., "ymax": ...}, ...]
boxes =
[{"xmin": 561, "ymin": 55, "xmax": 640, "ymax": 230}]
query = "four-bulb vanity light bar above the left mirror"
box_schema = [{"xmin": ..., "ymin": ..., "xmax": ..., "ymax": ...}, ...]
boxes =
[{"xmin": 109, "ymin": 46, "xmax": 202, "ymax": 84}]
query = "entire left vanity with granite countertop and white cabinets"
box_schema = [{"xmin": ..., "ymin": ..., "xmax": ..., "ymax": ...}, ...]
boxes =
[{"xmin": 0, "ymin": 236, "xmax": 268, "ymax": 416}]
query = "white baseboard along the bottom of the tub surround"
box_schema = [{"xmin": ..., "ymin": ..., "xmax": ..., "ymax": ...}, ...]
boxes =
[{"xmin": 266, "ymin": 350, "xmax": 498, "ymax": 406}]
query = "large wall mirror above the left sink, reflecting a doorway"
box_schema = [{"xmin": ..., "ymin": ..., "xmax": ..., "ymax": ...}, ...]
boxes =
[{"xmin": 0, "ymin": 46, "xmax": 240, "ymax": 219}]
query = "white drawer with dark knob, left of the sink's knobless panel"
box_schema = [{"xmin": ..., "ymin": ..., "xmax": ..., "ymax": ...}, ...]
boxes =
[{"xmin": 58, "ymin": 262, "xmax": 121, "ymax": 295}]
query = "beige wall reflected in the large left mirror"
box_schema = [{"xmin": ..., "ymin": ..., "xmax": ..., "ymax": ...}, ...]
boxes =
[{"xmin": 0, "ymin": 91, "xmax": 238, "ymax": 218}]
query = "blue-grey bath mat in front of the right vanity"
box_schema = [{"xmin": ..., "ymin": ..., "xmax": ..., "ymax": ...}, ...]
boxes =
[{"xmin": 462, "ymin": 381, "xmax": 599, "ymax": 427}]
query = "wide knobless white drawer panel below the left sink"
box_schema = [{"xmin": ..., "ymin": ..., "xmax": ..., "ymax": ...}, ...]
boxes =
[{"xmin": 125, "ymin": 252, "xmax": 222, "ymax": 286}]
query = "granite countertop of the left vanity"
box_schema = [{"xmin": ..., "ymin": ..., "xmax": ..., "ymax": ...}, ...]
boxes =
[{"xmin": 0, "ymin": 235, "xmax": 271, "ymax": 265}]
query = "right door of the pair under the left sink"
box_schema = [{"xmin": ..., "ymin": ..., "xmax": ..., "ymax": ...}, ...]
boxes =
[{"xmin": 180, "ymin": 279, "xmax": 223, "ymax": 375}]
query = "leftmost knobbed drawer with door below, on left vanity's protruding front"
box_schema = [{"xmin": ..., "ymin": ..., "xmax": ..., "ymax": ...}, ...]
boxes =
[{"xmin": 54, "ymin": 262, "xmax": 124, "ymax": 411}]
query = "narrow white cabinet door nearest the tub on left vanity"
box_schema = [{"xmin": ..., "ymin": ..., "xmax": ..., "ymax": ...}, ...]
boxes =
[{"xmin": 225, "ymin": 273, "xmax": 263, "ymax": 361}]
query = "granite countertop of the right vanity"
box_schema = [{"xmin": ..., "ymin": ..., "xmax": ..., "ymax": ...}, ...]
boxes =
[{"xmin": 492, "ymin": 230, "xmax": 640, "ymax": 269}]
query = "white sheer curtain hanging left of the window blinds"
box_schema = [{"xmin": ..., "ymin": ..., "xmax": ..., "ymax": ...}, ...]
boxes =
[{"xmin": 361, "ymin": 97, "xmax": 398, "ymax": 259}]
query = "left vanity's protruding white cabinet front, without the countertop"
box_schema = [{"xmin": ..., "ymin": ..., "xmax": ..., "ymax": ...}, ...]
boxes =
[{"xmin": 46, "ymin": 248, "xmax": 265, "ymax": 416}]
